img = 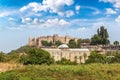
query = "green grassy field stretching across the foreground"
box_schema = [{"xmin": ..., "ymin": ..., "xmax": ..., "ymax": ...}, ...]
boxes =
[{"xmin": 0, "ymin": 64, "xmax": 120, "ymax": 80}]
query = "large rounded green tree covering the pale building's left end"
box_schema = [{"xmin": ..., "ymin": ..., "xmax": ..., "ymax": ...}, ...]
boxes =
[{"xmin": 23, "ymin": 49, "xmax": 54, "ymax": 65}]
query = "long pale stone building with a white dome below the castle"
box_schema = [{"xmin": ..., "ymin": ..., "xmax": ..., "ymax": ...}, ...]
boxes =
[{"xmin": 43, "ymin": 44, "xmax": 90, "ymax": 63}]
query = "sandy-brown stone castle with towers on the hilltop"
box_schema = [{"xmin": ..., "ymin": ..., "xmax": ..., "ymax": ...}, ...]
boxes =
[{"xmin": 28, "ymin": 34, "xmax": 78, "ymax": 47}]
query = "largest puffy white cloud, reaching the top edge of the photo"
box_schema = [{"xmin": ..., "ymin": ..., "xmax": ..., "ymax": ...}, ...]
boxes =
[{"xmin": 19, "ymin": 0, "xmax": 74, "ymax": 16}]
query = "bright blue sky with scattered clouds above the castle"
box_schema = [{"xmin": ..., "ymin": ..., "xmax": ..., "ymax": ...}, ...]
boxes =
[{"xmin": 0, "ymin": 0, "xmax": 120, "ymax": 52}]
